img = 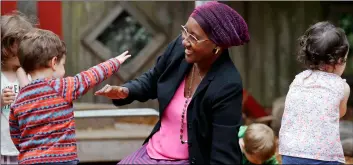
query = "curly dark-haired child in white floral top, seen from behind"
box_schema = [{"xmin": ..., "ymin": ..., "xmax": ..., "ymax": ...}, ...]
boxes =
[{"xmin": 279, "ymin": 22, "xmax": 350, "ymax": 164}]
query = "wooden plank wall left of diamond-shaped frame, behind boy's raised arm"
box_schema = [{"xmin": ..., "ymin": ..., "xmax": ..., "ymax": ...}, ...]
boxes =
[{"xmin": 62, "ymin": 1, "xmax": 118, "ymax": 105}]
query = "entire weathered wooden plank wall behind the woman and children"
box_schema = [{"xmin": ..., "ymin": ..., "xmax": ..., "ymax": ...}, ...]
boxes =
[{"xmin": 63, "ymin": 1, "xmax": 322, "ymax": 109}]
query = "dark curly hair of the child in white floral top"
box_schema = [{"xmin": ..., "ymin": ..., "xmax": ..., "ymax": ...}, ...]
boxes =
[{"xmin": 298, "ymin": 21, "xmax": 349, "ymax": 70}]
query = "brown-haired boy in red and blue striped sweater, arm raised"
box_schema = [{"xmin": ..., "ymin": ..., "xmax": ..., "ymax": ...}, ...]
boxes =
[{"xmin": 10, "ymin": 28, "xmax": 130, "ymax": 165}]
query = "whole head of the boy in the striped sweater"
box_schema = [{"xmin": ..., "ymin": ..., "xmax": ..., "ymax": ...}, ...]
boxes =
[{"xmin": 18, "ymin": 28, "xmax": 66, "ymax": 78}]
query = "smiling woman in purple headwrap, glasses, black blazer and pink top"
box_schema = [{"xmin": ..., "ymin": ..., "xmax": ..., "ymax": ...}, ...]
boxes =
[{"xmin": 96, "ymin": 2, "xmax": 249, "ymax": 164}]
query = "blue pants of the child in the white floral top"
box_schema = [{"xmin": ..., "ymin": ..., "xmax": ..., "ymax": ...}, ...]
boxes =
[{"xmin": 282, "ymin": 155, "xmax": 343, "ymax": 165}]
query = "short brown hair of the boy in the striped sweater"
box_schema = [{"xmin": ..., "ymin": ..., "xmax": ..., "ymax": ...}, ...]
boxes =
[{"xmin": 18, "ymin": 28, "xmax": 66, "ymax": 73}]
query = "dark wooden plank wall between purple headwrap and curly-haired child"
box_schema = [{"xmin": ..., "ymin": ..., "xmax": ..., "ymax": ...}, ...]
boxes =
[{"xmin": 227, "ymin": 1, "xmax": 322, "ymax": 106}]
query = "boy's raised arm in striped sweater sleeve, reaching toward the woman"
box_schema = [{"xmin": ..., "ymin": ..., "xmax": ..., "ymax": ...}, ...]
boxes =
[{"xmin": 49, "ymin": 51, "xmax": 130, "ymax": 102}]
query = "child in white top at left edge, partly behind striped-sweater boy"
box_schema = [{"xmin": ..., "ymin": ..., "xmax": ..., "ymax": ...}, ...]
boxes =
[{"xmin": 0, "ymin": 12, "xmax": 33, "ymax": 164}]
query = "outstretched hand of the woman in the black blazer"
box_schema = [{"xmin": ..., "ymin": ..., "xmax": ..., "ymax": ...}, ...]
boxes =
[{"xmin": 94, "ymin": 84, "xmax": 129, "ymax": 99}]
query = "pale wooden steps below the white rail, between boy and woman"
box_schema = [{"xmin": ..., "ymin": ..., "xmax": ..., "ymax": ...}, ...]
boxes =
[{"xmin": 76, "ymin": 123, "xmax": 153, "ymax": 163}]
